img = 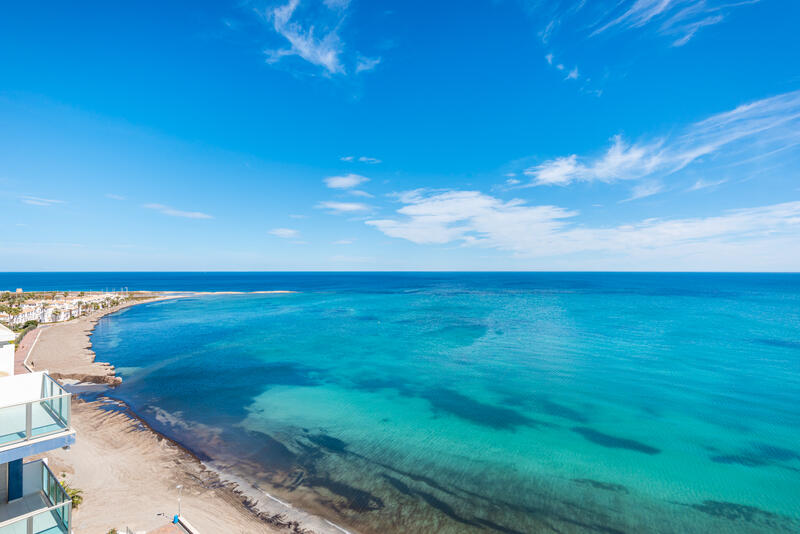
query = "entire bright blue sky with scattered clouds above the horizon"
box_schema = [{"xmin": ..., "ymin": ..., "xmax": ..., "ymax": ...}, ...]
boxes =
[{"xmin": 0, "ymin": 0, "xmax": 800, "ymax": 271}]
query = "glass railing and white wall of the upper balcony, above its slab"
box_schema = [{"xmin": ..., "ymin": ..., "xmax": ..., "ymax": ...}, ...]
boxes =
[{"xmin": 0, "ymin": 373, "xmax": 71, "ymax": 448}]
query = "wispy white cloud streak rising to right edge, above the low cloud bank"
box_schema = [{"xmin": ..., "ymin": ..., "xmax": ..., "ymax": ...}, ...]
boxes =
[{"xmin": 524, "ymin": 91, "xmax": 800, "ymax": 191}]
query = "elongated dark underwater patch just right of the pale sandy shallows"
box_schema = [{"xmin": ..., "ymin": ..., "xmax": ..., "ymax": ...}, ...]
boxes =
[{"xmin": 421, "ymin": 388, "xmax": 541, "ymax": 430}]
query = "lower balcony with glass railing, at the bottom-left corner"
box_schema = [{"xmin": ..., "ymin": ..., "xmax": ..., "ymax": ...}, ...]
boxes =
[{"xmin": 0, "ymin": 460, "xmax": 72, "ymax": 534}]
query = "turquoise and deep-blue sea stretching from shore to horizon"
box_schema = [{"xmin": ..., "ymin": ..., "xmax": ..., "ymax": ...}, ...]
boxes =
[{"xmin": 87, "ymin": 273, "xmax": 800, "ymax": 534}]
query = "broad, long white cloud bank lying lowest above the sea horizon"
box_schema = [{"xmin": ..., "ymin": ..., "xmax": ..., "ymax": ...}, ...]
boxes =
[{"xmin": 366, "ymin": 190, "xmax": 800, "ymax": 270}]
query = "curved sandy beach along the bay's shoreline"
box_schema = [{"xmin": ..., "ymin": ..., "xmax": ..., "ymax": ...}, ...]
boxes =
[{"xmin": 23, "ymin": 296, "xmax": 341, "ymax": 534}]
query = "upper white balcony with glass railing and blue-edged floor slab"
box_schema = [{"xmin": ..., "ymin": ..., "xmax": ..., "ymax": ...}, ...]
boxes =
[{"xmin": 0, "ymin": 372, "xmax": 75, "ymax": 464}]
